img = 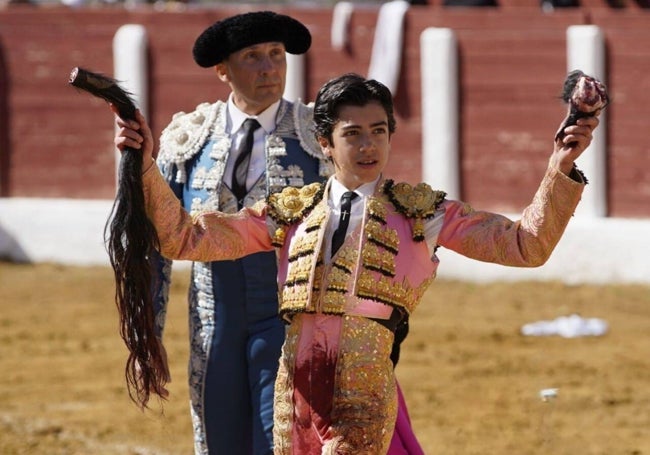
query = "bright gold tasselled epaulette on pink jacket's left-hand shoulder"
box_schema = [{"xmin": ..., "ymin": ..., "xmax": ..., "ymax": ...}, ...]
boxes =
[{"xmin": 267, "ymin": 182, "xmax": 325, "ymax": 248}]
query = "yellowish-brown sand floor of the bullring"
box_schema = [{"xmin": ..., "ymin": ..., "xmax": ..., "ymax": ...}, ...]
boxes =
[{"xmin": 0, "ymin": 263, "xmax": 650, "ymax": 455}]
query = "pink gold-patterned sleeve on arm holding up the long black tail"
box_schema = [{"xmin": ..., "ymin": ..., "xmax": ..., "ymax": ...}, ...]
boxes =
[{"xmin": 142, "ymin": 166, "xmax": 273, "ymax": 262}]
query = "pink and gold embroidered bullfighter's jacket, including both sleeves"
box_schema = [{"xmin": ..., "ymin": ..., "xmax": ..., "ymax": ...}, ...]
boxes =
[{"xmin": 143, "ymin": 164, "xmax": 585, "ymax": 328}]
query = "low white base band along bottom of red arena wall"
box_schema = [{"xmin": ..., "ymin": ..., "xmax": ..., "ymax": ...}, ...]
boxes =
[{"xmin": 0, "ymin": 198, "xmax": 650, "ymax": 284}]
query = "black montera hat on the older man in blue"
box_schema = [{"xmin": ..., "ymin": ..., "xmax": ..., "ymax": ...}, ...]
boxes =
[{"xmin": 192, "ymin": 11, "xmax": 311, "ymax": 68}]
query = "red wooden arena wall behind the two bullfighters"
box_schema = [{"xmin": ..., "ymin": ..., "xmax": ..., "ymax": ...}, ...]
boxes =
[{"xmin": 0, "ymin": 0, "xmax": 650, "ymax": 218}]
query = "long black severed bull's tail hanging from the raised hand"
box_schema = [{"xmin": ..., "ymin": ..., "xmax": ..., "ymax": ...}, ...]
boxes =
[{"xmin": 69, "ymin": 68, "xmax": 168, "ymax": 408}]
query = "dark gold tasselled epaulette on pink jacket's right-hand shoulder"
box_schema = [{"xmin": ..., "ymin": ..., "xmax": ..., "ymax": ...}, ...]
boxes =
[{"xmin": 382, "ymin": 180, "xmax": 447, "ymax": 242}]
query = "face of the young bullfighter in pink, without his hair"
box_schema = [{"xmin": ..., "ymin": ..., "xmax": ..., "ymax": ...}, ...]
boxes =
[{"xmin": 319, "ymin": 101, "xmax": 390, "ymax": 190}]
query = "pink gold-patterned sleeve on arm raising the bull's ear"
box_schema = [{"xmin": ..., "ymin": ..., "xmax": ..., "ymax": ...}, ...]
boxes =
[{"xmin": 438, "ymin": 168, "xmax": 584, "ymax": 267}]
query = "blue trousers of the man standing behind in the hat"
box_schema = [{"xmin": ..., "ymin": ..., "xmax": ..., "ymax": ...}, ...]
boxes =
[{"xmin": 195, "ymin": 253, "xmax": 285, "ymax": 455}]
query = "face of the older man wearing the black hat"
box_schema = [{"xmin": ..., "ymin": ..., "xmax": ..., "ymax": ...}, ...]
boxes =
[{"xmin": 216, "ymin": 42, "xmax": 287, "ymax": 115}]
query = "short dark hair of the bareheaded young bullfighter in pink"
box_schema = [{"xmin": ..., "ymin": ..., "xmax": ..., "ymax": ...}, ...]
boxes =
[{"xmin": 314, "ymin": 73, "xmax": 397, "ymax": 143}]
